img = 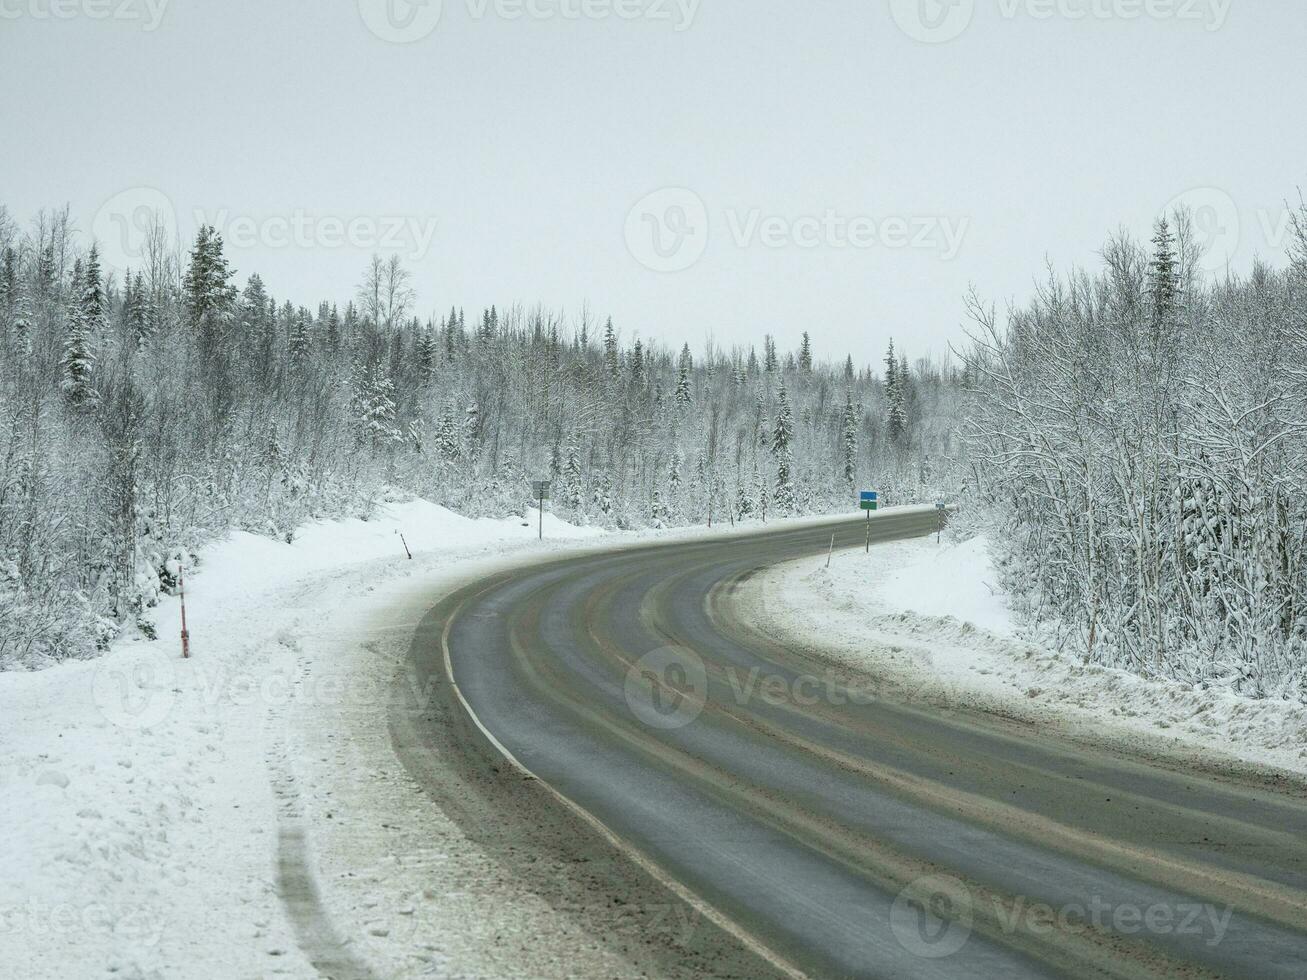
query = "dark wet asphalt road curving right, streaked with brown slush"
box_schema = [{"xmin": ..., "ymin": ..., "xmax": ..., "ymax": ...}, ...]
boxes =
[{"xmin": 440, "ymin": 511, "xmax": 1307, "ymax": 977}]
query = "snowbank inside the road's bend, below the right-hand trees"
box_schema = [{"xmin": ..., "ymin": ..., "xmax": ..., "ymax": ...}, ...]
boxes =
[{"xmin": 741, "ymin": 537, "xmax": 1307, "ymax": 774}]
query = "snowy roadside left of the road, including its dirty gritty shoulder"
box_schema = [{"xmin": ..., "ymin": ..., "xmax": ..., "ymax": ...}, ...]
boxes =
[{"xmin": 0, "ymin": 500, "xmax": 852, "ymax": 980}]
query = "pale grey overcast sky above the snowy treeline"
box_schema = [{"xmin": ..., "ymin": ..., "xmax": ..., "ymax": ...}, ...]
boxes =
[{"xmin": 0, "ymin": 0, "xmax": 1307, "ymax": 362}]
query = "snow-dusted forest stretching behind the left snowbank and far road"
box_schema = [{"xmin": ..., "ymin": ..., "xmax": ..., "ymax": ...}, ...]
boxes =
[{"xmin": 0, "ymin": 208, "xmax": 961, "ymax": 668}]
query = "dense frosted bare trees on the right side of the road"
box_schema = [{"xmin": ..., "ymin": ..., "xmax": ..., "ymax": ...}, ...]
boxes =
[{"xmin": 963, "ymin": 205, "xmax": 1307, "ymax": 698}]
